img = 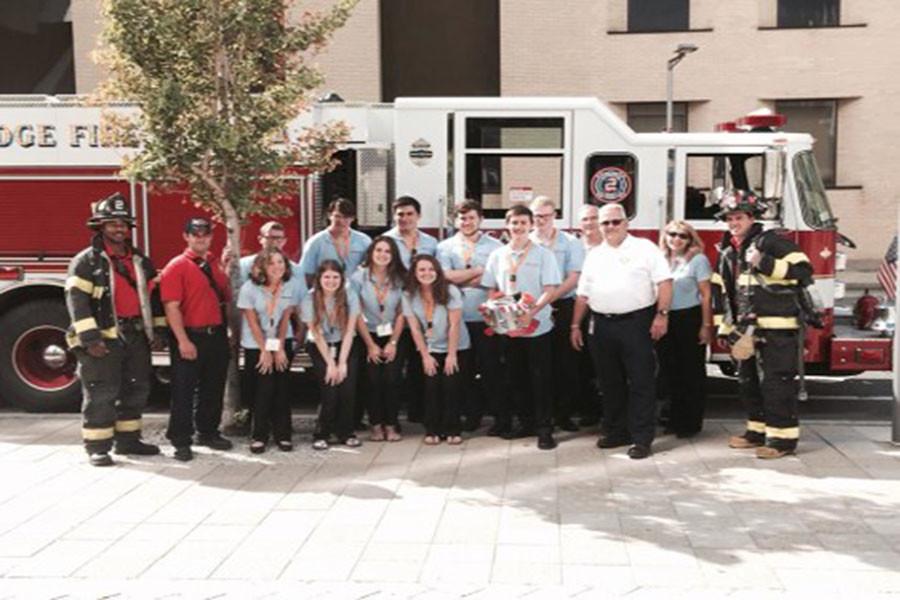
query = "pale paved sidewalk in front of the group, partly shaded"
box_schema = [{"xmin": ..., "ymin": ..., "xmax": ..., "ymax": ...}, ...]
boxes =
[{"xmin": 0, "ymin": 415, "xmax": 900, "ymax": 600}]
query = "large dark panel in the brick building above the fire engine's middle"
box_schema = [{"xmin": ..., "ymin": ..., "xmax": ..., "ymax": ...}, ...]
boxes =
[{"xmin": 379, "ymin": 0, "xmax": 500, "ymax": 102}]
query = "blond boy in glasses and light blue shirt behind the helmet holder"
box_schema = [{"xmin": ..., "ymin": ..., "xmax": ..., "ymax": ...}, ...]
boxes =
[{"xmin": 530, "ymin": 196, "xmax": 584, "ymax": 431}]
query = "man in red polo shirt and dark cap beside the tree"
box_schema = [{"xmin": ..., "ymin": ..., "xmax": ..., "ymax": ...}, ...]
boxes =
[{"xmin": 160, "ymin": 218, "xmax": 232, "ymax": 461}]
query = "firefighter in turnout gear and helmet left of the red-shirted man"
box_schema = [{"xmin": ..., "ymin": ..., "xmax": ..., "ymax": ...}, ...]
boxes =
[{"xmin": 66, "ymin": 193, "xmax": 166, "ymax": 466}]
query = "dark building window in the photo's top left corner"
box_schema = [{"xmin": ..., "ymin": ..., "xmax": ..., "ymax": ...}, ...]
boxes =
[{"xmin": 0, "ymin": 0, "xmax": 75, "ymax": 94}]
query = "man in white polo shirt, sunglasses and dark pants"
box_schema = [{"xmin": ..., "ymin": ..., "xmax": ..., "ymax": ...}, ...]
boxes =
[{"xmin": 571, "ymin": 204, "xmax": 672, "ymax": 459}]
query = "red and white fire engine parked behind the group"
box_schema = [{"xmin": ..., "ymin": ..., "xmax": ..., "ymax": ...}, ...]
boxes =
[{"xmin": 0, "ymin": 96, "xmax": 891, "ymax": 410}]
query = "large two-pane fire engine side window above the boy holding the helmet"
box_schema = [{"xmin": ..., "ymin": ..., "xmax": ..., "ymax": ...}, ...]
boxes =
[{"xmin": 465, "ymin": 117, "xmax": 565, "ymax": 219}]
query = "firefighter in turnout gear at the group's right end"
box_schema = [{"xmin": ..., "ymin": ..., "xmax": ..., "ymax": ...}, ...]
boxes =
[{"xmin": 711, "ymin": 190, "xmax": 813, "ymax": 458}]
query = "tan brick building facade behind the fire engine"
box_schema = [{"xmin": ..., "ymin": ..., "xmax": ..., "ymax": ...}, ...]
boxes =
[{"xmin": 17, "ymin": 0, "xmax": 900, "ymax": 261}]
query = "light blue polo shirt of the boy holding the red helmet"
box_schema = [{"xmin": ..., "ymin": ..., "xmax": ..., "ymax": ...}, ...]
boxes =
[{"xmin": 481, "ymin": 243, "xmax": 562, "ymax": 337}]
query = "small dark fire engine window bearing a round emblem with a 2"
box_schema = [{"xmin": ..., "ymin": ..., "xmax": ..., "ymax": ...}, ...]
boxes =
[{"xmin": 584, "ymin": 154, "xmax": 637, "ymax": 218}]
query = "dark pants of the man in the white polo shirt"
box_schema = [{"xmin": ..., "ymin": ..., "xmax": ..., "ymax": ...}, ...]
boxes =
[{"xmin": 590, "ymin": 306, "xmax": 656, "ymax": 446}]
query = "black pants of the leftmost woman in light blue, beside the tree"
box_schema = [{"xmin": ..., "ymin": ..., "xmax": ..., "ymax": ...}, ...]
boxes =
[{"xmin": 244, "ymin": 339, "xmax": 294, "ymax": 443}]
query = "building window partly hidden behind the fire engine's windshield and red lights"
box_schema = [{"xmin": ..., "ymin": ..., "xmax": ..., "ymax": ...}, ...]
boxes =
[{"xmin": 775, "ymin": 100, "xmax": 837, "ymax": 187}]
